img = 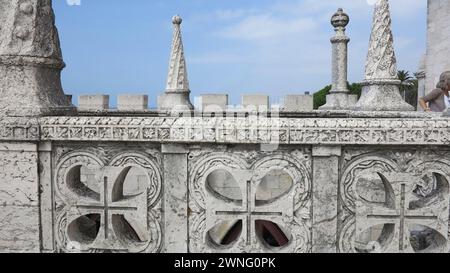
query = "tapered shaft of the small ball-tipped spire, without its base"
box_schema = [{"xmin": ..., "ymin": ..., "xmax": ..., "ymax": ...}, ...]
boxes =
[{"xmin": 166, "ymin": 15, "xmax": 189, "ymax": 92}]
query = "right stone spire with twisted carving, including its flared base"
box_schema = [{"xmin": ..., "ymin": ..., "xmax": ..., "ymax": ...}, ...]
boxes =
[{"xmin": 355, "ymin": 0, "xmax": 414, "ymax": 111}]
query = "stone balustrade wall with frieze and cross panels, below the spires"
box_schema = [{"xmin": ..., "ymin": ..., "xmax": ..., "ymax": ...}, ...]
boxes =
[{"xmin": 0, "ymin": 112, "xmax": 450, "ymax": 253}]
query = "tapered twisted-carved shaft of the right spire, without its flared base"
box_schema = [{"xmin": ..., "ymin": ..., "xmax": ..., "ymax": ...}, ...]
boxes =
[{"xmin": 365, "ymin": 0, "xmax": 398, "ymax": 80}]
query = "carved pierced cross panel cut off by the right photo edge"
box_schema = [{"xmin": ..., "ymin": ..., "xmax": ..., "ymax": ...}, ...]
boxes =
[{"xmin": 339, "ymin": 151, "xmax": 450, "ymax": 252}]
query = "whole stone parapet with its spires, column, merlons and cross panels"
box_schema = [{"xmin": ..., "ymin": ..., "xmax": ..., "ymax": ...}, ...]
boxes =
[{"xmin": 0, "ymin": 0, "xmax": 450, "ymax": 253}]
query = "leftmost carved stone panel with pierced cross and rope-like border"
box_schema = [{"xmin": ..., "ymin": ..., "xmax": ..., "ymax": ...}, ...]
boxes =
[{"xmin": 54, "ymin": 150, "xmax": 162, "ymax": 252}]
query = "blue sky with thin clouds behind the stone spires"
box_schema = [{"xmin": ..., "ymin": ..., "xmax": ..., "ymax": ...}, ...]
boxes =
[{"xmin": 53, "ymin": 0, "xmax": 426, "ymax": 107}]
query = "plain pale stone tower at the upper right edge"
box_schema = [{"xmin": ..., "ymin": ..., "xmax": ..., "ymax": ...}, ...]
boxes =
[{"xmin": 425, "ymin": 0, "xmax": 450, "ymax": 94}]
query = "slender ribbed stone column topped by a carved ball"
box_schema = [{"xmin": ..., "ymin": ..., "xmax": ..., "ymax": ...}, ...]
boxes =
[{"xmin": 320, "ymin": 9, "xmax": 357, "ymax": 110}]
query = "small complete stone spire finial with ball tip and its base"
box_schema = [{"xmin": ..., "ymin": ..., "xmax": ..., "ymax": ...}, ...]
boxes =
[{"xmin": 159, "ymin": 15, "xmax": 193, "ymax": 110}]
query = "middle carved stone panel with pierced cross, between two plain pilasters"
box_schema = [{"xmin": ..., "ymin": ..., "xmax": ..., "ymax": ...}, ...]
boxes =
[{"xmin": 189, "ymin": 150, "xmax": 311, "ymax": 253}]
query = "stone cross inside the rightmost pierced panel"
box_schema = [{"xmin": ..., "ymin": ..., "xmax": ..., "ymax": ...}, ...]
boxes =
[{"xmin": 355, "ymin": 172, "xmax": 449, "ymax": 252}]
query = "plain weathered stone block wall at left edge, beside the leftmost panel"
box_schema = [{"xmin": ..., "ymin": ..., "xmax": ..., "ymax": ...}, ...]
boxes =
[{"xmin": 0, "ymin": 142, "xmax": 40, "ymax": 252}]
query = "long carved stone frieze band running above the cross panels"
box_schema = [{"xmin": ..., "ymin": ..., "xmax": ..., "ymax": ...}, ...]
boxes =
[{"xmin": 37, "ymin": 116, "xmax": 450, "ymax": 145}]
